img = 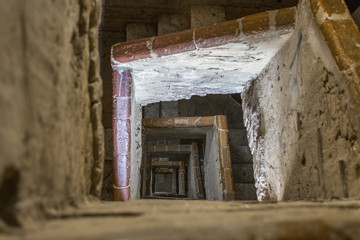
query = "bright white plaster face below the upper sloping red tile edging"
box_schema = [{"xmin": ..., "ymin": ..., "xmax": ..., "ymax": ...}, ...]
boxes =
[{"xmin": 114, "ymin": 30, "xmax": 291, "ymax": 106}]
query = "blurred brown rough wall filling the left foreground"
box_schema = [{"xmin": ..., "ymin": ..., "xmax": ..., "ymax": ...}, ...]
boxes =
[{"xmin": 0, "ymin": 0, "xmax": 104, "ymax": 226}]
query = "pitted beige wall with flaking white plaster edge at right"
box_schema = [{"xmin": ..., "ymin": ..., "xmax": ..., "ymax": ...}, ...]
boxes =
[{"xmin": 242, "ymin": 1, "xmax": 360, "ymax": 200}]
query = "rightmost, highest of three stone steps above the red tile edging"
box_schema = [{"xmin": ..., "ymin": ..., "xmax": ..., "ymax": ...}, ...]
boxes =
[{"xmin": 190, "ymin": 6, "xmax": 226, "ymax": 28}]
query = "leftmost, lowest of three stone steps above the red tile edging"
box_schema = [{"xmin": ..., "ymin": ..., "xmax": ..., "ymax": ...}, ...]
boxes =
[{"xmin": 126, "ymin": 23, "xmax": 157, "ymax": 41}]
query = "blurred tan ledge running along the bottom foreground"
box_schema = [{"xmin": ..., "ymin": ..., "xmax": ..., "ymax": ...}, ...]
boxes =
[{"xmin": 0, "ymin": 200, "xmax": 360, "ymax": 240}]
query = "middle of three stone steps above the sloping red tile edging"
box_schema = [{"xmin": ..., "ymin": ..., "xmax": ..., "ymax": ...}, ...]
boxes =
[{"xmin": 158, "ymin": 14, "xmax": 190, "ymax": 35}]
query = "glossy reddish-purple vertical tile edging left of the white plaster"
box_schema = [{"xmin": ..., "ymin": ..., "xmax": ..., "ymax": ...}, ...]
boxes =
[{"xmin": 112, "ymin": 70, "xmax": 132, "ymax": 202}]
